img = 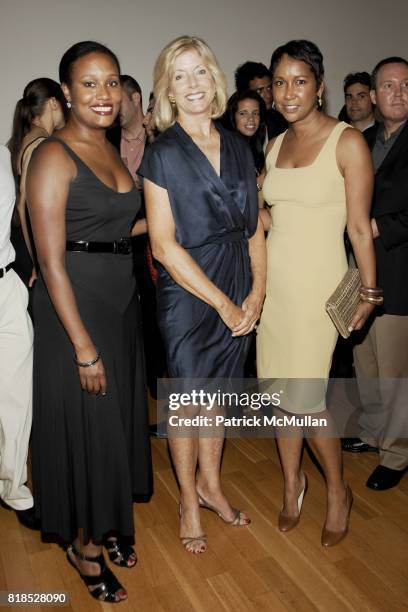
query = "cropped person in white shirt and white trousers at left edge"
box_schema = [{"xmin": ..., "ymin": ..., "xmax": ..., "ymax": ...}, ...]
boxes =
[{"xmin": 0, "ymin": 145, "xmax": 39, "ymax": 529}]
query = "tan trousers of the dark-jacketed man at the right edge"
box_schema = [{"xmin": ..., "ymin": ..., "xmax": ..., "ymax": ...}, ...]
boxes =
[{"xmin": 354, "ymin": 315, "xmax": 408, "ymax": 470}]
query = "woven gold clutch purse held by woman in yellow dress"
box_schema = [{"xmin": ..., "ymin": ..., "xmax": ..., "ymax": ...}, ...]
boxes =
[{"xmin": 326, "ymin": 268, "xmax": 361, "ymax": 338}]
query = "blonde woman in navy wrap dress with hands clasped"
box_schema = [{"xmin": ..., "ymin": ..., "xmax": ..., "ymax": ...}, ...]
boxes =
[{"xmin": 140, "ymin": 36, "xmax": 265, "ymax": 553}]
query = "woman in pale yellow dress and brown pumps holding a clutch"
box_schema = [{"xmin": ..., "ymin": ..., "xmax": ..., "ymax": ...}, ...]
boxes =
[{"xmin": 257, "ymin": 40, "xmax": 375, "ymax": 546}]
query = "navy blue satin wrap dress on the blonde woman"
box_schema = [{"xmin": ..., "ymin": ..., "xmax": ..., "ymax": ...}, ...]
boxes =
[{"xmin": 139, "ymin": 123, "xmax": 258, "ymax": 378}]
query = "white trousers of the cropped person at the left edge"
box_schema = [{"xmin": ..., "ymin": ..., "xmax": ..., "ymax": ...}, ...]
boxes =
[{"xmin": 0, "ymin": 270, "xmax": 33, "ymax": 510}]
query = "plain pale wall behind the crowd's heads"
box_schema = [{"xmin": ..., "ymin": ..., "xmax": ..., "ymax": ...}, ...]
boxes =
[{"xmin": 0, "ymin": 0, "xmax": 408, "ymax": 142}]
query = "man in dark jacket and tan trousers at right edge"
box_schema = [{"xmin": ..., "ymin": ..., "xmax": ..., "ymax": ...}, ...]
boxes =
[{"xmin": 343, "ymin": 57, "xmax": 408, "ymax": 490}]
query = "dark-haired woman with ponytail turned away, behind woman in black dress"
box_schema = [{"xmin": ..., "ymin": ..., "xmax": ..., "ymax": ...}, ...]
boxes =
[{"xmin": 8, "ymin": 77, "xmax": 66, "ymax": 287}]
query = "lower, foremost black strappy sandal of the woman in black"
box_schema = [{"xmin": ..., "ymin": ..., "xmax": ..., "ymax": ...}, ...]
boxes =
[{"xmin": 67, "ymin": 544, "xmax": 125, "ymax": 603}]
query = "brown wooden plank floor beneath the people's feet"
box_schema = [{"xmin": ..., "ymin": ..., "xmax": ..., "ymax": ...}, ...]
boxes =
[{"xmin": 0, "ymin": 439, "xmax": 408, "ymax": 612}]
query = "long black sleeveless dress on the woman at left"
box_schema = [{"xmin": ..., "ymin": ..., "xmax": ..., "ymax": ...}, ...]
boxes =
[{"xmin": 33, "ymin": 138, "xmax": 152, "ymax": 542}]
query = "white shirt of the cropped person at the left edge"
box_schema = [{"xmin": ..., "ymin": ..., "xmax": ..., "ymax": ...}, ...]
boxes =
[{"xmin": 0, "ymin": 145, "xmax": 16, "ymax": 269}]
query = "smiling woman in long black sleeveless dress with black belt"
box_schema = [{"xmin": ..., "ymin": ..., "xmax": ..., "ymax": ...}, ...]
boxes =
[{"xmin": 27, "ymin": 42, "xmax": 151, "ymax": 602}]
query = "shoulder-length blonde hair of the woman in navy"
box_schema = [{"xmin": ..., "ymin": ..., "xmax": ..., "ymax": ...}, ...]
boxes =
[{"xmin": 153, "ymin": 36, "xmax": 227, "ymax": 132}]
